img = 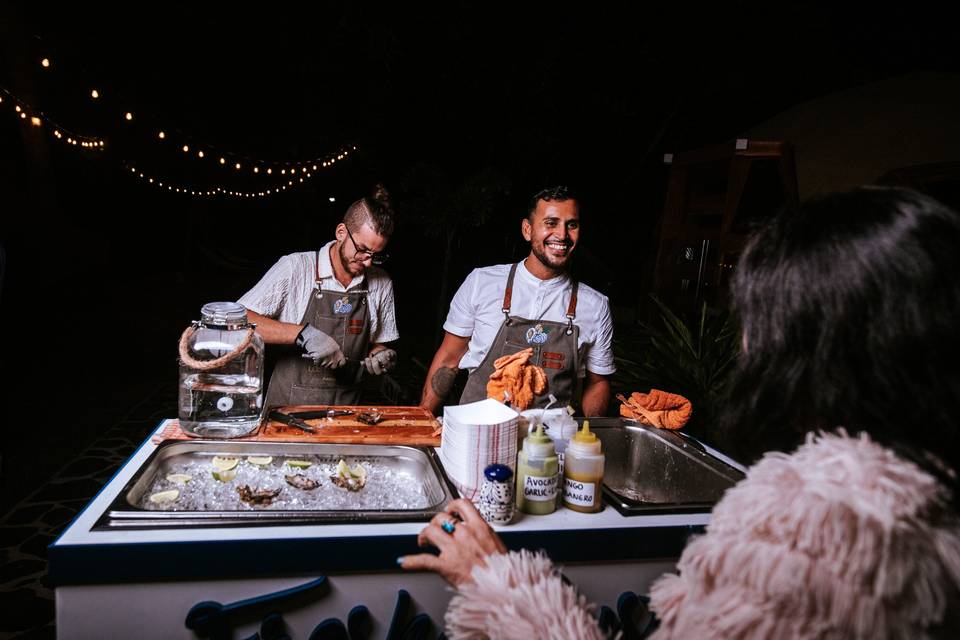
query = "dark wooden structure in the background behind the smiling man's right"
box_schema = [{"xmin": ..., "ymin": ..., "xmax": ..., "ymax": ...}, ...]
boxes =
[{"xmin": 653, "ymin": 139, "xmax": 798, "ymax": 312}]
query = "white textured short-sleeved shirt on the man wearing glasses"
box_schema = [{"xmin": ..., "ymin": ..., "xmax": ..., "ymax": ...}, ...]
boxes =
[{"xmin": 237, "ymin": 240, "xmax": 400, "ymax": 343}]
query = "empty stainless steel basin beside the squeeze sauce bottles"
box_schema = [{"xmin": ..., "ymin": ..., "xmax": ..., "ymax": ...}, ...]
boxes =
[{"xmin": 590, "ymin": 418, "xmax": 743, "ymax": 515}]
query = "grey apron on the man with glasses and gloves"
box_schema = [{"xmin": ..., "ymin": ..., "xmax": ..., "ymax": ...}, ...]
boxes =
[{"xmin": 266, "ymin": 251, "xmax": 370, "ymax": 407}]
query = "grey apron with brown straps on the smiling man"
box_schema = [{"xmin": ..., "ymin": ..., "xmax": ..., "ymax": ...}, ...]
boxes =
[{"xmin": 460, "ymin": 265, "xmax": 580, "ymax": 409}]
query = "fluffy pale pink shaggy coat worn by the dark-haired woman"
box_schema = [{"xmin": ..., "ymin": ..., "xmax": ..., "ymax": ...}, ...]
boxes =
[{"xmin": 446, "ymin": 433, "xmax": 960, "ymax": 640}]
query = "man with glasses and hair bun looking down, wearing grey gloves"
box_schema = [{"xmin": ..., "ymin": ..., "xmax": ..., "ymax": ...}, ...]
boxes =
[{"xmin": 246, "ymin": 185, "xmax": 399, "ymax": 407}]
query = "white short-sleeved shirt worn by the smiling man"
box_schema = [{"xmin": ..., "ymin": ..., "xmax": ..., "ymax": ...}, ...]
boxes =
[{"xmin": 443, "ymin": 261, "xmax": 617, "ymax": 378}]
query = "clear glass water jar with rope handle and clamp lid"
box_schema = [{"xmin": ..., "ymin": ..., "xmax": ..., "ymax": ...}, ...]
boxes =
[{"xmin": 178, "ymin": 302, "xmax": 263, "ymax": 438}]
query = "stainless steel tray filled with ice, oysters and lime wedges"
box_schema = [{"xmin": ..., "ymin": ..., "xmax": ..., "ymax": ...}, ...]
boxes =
[{"xmin": 95, "ymin": 440, "xmax": 457, "ymax": 529}]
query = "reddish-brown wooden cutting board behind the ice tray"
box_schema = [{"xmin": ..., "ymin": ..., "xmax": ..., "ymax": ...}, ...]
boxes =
[{"xmin": 157, "ymin": 405, "xmax": 440, "ymax": 447}]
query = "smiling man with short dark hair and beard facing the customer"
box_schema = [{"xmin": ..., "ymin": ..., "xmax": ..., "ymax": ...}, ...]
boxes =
[{"xmin": 420, "ymin": 187, "xmax": 616, "ymax": 416}]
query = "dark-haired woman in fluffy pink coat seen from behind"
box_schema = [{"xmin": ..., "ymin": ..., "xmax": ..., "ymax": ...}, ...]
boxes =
[{"xmin": 402, "ymin": 187, "xmax": 960, "ymax": 638}]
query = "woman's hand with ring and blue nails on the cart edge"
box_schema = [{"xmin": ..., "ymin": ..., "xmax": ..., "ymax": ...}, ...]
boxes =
[{"xmin": 400, "ymin": 498, "xmax": 507, "ymax": 587}]
